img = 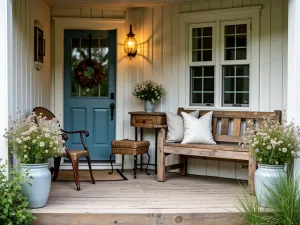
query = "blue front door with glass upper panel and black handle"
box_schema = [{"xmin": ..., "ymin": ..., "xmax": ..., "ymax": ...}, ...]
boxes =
[{"xmin": 64, "ymin": 30, "xmax": 117, "ymax": 160}]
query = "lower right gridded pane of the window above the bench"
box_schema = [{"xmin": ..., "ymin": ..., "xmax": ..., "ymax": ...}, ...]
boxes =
[{"xmin": 222, "ymin": 65, "xmax": 249, "ymax": 107}]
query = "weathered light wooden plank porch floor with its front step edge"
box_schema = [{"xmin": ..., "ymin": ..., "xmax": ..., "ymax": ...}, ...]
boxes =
[{"xmin": 33, "ymin": 171, "xmax": 246, "ymax": 225}]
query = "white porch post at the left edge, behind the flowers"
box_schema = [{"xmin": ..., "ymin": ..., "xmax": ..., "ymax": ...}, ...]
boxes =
[{"xmin": 0, "ymin": 0, "xmax": 12, "ymax": 163}]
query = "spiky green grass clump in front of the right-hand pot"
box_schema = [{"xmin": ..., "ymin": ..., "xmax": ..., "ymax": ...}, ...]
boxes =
[{"xmin": 237, "ymin": 176, "xmax": 300, "ymax": 225}]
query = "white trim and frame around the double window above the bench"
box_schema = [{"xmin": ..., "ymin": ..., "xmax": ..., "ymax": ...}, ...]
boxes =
[{"xmin": 178, "ymin": 6, "xmax": 261, "ymax": 111}]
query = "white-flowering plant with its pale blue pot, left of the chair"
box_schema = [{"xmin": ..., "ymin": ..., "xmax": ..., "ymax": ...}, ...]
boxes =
[{"xmin": 4, "ymin": 111, "xmax": 65, "ymax": 208}]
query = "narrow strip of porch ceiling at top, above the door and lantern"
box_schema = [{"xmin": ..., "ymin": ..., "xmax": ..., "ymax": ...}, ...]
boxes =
[{"xmin": 47, "ymin": 0, "xmax": 193, "ymax": 8}]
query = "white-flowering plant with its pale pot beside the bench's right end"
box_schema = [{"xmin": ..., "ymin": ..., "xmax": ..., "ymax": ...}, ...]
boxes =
[{"xmin": 245, "ymin": 115, "xmax": 300, "ymax": 206}]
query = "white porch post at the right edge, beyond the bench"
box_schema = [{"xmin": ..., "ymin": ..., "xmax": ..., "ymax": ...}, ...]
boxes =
[{"xmin": 287, "ymin": 0, "xmax": 300, "ymax": 176}]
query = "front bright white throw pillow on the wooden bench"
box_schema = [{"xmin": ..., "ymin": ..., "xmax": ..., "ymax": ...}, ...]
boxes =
[{"xmin": 181, "ymin": 112, "xmax": 216, "ymax": 144}]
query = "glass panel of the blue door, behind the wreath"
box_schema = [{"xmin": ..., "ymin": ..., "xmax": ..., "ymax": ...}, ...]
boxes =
[{"xmin": 71, "ymin": 37, "xmax": 109, "ymax": 97}]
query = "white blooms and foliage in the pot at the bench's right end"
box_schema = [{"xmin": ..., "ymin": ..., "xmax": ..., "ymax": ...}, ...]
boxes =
[{"xmin": 244, "ymin": 115, "xmax": 300, "ymax": 165}]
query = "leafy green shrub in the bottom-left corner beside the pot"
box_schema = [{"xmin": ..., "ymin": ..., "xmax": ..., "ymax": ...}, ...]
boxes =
[{"xmin": 0, "ymin": 165, "xmax": 35, "ymax": 225}]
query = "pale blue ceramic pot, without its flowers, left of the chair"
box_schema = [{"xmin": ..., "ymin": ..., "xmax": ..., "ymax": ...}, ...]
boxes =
[{"xmin": 21, "ymin": 163, "xmax": 51, "ymax": 209}]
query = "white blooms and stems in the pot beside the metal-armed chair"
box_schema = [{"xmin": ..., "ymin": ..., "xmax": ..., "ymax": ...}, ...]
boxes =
[{"xmin": 4, "ymin": 110, "xmax": 65, "ymax": 164}]
